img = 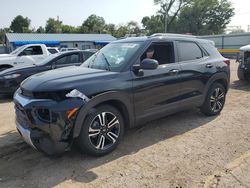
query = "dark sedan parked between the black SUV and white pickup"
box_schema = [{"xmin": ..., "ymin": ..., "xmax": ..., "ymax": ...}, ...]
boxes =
[{"xmin": 0, "ymin": 50, "xmax": 94, "ymax": 94}]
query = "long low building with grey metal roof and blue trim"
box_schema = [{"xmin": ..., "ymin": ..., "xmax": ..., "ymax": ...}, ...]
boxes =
[{"xmin": 5, "ymin": 33, "xmax": 116, "ymax": 52}]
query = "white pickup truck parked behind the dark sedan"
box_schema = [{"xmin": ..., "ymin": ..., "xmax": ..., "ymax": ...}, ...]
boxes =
[{"xmin": 0, "ymin": 44, "xmax": 51, "ymax": 71}]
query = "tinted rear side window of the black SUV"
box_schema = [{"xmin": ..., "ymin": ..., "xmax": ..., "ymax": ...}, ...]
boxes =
[{"xmin": 178, "ymin": 41, "xmax": 203, "ymax": 61}]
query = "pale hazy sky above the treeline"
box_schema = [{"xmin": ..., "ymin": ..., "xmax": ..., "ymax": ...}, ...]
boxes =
[{"xmin": 0, "ymin": 0, "xmax": 250, "ymax": 29}]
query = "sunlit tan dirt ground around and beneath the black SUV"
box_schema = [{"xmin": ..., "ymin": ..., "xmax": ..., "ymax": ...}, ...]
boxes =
[{"xmin": 0, "ymin": 62, "xmax": 250, "ymax": 188}]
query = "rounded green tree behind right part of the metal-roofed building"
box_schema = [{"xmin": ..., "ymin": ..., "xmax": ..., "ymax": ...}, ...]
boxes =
[{"xmin": 81, "ymin": 14, "xmax": 105, "ymax": 33}]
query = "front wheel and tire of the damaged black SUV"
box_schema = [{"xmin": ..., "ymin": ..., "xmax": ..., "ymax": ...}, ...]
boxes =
[{"xmin": 77, "ymin": 105, "xmax": 124, "ymax": 156}]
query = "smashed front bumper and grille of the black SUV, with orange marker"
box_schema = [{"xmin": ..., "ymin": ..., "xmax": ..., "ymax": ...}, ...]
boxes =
[{"xmin": 14, "ymin": 91, "xmax": 86, "ymax": 155}]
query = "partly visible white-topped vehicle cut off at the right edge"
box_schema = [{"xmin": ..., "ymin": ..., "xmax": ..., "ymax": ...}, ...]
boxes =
[{"xmin": 237, "ymin": 45, "xmax": 250, "ymax": 80}]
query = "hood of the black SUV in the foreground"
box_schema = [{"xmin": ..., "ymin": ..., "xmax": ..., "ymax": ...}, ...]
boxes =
[{"xmin": 21, "ymin": 66, "xmax": 118, "ymax": 92}]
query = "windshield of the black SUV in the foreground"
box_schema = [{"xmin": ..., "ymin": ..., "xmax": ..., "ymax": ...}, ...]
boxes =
[{"xmin": 81, "ymin": 42, "xmax": 141, "ymax": 71}]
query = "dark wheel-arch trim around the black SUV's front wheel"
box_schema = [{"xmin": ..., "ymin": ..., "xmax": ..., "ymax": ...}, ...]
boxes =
[{"xmin": 73, "ymin": 91, "xmax": 135, "ymax": 138}]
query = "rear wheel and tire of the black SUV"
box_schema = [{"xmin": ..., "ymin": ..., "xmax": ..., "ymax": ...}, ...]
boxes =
[{"xmin": 201, "ymin": 83, "xmax": 226, "ymax": 116}]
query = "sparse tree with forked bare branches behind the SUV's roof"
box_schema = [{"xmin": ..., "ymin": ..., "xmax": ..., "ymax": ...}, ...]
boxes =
[{"xmin": 154, "ymin": 0, "xmax": 190, "ymax": 32}]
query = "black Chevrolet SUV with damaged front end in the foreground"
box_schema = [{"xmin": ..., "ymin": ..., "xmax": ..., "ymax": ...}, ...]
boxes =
[{"xmin": 14, "ymin": 34, "xmax": 230, "ymax": 156}]
